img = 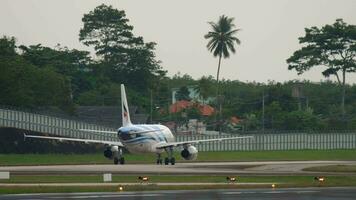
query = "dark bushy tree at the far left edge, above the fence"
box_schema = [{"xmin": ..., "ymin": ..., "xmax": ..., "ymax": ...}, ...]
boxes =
[{"xmin": 0, "ymin": 37, "xmax": 74, "ymax": 112}]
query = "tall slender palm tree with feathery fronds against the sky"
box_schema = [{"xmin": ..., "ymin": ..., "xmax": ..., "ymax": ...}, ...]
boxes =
[{"xmin": 204, "ymin": 15, "xmax": 240, "ymax": 133}]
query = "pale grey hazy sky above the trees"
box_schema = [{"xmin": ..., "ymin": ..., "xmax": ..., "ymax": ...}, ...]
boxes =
[{"xmin": 0, "ymin": 0, "xmax": 356, "ymax": 83}]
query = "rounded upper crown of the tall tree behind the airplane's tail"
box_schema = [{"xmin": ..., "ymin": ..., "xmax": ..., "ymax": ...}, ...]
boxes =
[{"xmin": 79, "ymin": 4, "xmax": 143, "ymax": 63}]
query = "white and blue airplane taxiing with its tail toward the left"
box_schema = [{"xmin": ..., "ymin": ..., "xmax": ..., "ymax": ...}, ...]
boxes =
[{"xmin": 24, "ymin": 84, "xmax": 253, "ymax": 165}]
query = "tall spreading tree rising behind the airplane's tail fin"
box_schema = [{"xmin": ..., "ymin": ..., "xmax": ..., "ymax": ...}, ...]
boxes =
[{"xmin": 79, "ymin": 4, "xmax": 166, "ymax": 94}]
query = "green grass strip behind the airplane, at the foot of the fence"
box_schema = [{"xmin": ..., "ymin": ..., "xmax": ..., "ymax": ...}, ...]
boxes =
[{"xmin": 0, "ymin": 149, "xmax": 356, "ymax": 166}]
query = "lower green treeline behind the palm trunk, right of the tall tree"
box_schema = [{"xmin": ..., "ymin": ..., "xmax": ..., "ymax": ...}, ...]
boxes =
[{"xmin": 161, "ymin": 75, "xmax": 356, "ymax": 131}]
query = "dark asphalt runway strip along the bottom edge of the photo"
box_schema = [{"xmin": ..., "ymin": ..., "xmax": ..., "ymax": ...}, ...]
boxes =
[{"xmin": 0, "ymin": 187, "xmax": 356, "ymax": 200}]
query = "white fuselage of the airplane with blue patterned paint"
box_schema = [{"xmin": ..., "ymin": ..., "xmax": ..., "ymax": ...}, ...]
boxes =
[{"xmin": 118, "ymin": 124, "xmax": 175, "ymax": 154}]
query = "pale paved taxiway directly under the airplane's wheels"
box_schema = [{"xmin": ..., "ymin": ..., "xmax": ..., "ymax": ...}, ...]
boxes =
[{"xmin": 0, "ymin": 161, "xmax": 356, "ymax": 175}]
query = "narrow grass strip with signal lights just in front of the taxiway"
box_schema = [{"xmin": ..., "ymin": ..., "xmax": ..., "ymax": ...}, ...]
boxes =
[{"xmin": 0, "ymin": 175, "xmax": 356, "ymax": 185}]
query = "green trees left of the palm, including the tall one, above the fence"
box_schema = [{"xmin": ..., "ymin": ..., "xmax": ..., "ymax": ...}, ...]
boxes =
[{"xmin": 0, "ymin": 4, "xmax": 166, "ymax": 115}]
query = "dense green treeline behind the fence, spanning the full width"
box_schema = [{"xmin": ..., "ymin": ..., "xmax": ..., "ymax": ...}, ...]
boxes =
[{"xmin": 0, "ymin": 5, "xmax": 356, "ymax": 131}]
